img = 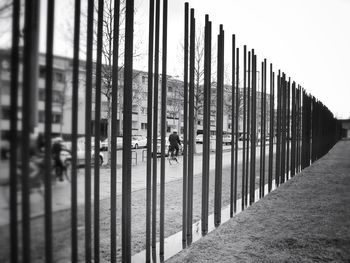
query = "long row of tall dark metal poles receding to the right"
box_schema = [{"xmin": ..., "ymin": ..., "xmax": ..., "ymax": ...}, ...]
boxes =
[{"xmin": 3, "ymin": 0, "xmax": 341, "ymax": 262}]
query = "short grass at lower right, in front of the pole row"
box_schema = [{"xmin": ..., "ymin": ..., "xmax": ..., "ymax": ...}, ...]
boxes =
[{"xmin": 168, "ymin": 141, "xmax": 350, "ymax": 263}]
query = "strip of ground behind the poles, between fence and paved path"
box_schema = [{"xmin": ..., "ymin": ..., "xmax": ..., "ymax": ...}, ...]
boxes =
[{"xmin": 0, "ymin": 151, "xmax": 268, "ymax": 262}]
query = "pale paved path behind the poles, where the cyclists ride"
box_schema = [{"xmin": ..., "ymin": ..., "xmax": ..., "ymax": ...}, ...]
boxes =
[{"xmin": 0, "ymin": 142, "xmax": 268, "ymax": 225}]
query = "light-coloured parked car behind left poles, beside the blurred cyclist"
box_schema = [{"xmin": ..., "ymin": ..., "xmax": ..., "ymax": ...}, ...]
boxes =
[{"xmin": 60, "ymin": 140, "xmax": 103, "ymax": 166}]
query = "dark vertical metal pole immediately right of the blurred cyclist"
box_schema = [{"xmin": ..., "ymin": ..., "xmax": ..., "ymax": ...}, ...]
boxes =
[{"xmin": 71, "ymin": 0, "xmax": 80, "ymax": 262}]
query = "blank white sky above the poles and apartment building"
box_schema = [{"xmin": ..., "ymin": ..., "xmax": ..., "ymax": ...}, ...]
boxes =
[{"xmin": 0, "ymin": 0, "xmax": 350, "ymax": 118}]
